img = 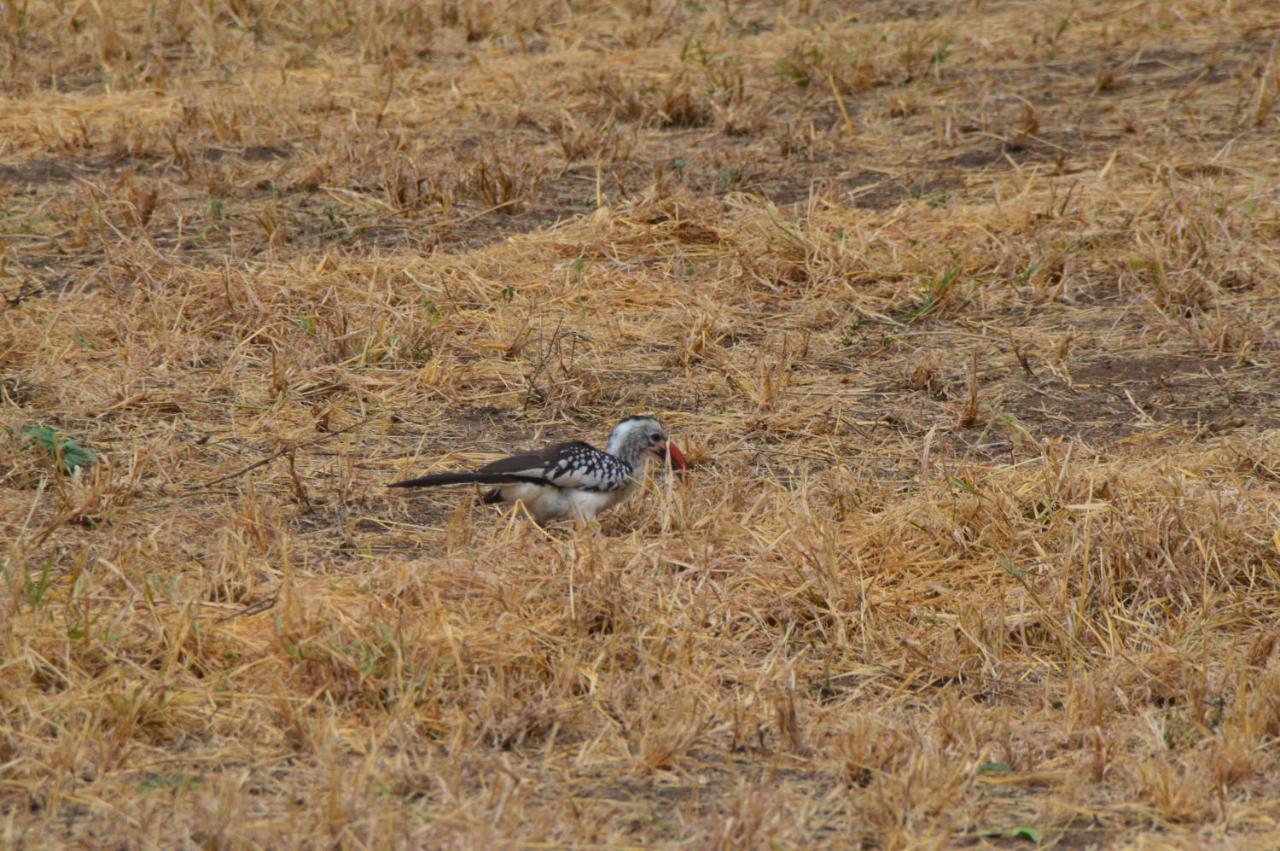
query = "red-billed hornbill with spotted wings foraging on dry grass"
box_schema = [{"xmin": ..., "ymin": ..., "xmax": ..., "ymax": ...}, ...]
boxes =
[{"xmin": 388, "ymin": 415, "xmax": 687, "ymax": 526}]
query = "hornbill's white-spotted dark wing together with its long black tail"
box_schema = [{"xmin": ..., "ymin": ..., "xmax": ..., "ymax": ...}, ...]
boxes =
[{"xmin": 390, "ymin": 441, "xmax": 632, "ymax": 491}]
